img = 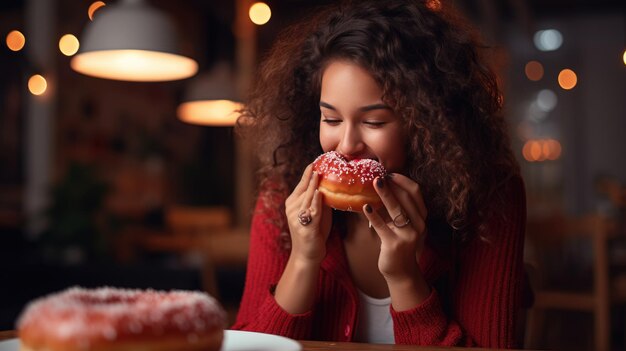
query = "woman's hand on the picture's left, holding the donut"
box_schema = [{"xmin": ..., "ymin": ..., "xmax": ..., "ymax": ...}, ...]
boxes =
[{"xmin": 285, "ymin": 165, "xmax": 332, "ymax": 264}]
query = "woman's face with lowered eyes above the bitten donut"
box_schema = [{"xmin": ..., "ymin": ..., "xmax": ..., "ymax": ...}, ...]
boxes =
[{"xmin": 320, "ymin": 61, "xmax": 406, "ymax": 172}]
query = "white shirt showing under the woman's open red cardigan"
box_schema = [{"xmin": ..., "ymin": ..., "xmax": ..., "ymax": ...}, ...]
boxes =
[{"xmin": 354, "ymin": 289, "xmax": 395, "ymax": 344}]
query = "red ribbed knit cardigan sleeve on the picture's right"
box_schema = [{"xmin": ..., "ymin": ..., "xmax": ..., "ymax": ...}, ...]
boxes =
[{"xmin": 391, "ymin": 178, "xmax": 526, "ymax": 348}]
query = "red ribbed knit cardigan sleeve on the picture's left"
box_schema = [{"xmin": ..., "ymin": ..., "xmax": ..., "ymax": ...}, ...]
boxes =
[{"xmin": 231, "ymin": 197, "xmax": 312, "ymax": 339}]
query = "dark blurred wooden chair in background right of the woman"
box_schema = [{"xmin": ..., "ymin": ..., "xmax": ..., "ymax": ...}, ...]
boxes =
[{"xmin": 525, "ymin": 214, "xmax": 626, "ymax": 351}]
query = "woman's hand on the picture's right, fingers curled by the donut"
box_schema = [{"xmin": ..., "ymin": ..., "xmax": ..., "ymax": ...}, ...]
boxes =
[{"xmin": 363, "ymin": 173, "xmax": 427, "ymax": 284}]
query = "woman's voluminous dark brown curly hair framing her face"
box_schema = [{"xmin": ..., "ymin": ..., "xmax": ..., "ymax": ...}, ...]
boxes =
[{"xmin": 238, "ymin": 0, "xmax": 519, "ymax": 245}]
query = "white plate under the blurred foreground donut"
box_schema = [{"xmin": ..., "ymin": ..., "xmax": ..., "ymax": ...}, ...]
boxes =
[{"xmin": 0, "ymin": 330, "xmax": 302, "ymax": 351}]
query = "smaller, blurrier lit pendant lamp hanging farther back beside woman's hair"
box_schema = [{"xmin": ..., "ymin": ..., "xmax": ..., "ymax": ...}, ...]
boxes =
[{"xmin": 177, "ymin": 61, "xmax": 243, "ymax": 126}]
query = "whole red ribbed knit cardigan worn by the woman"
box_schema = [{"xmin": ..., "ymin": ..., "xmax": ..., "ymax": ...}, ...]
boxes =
[{"xmin": 232, "ymin": 178, "xmax": 526, "ymax": 348}]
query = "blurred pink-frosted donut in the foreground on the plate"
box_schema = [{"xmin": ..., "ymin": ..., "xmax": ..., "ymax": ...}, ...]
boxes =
[{"xmin": 17, "ymin": 287, "xmax": 226, "ymax": 351}]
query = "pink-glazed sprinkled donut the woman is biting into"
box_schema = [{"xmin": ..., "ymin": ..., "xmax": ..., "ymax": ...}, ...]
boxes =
[{"xmin": 313, "ymin": 151, "xmax": 387, "ymax": 212}]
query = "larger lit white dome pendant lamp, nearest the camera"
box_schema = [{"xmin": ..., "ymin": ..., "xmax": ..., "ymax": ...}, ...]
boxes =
[{"xmin": 71, "ymin": 0, "xmax": 198, "ymax": 82}]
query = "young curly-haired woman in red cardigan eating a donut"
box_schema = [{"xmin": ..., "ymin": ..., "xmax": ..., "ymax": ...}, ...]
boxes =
[{"xmin": 233, "ymin": 0, "xmax": 526, "ymax": 347}]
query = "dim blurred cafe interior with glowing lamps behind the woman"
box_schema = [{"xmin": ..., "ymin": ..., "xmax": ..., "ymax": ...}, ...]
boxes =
[{"xmin": 0, "ymin": 0, "xmax": 626, "ymax": 351}]
